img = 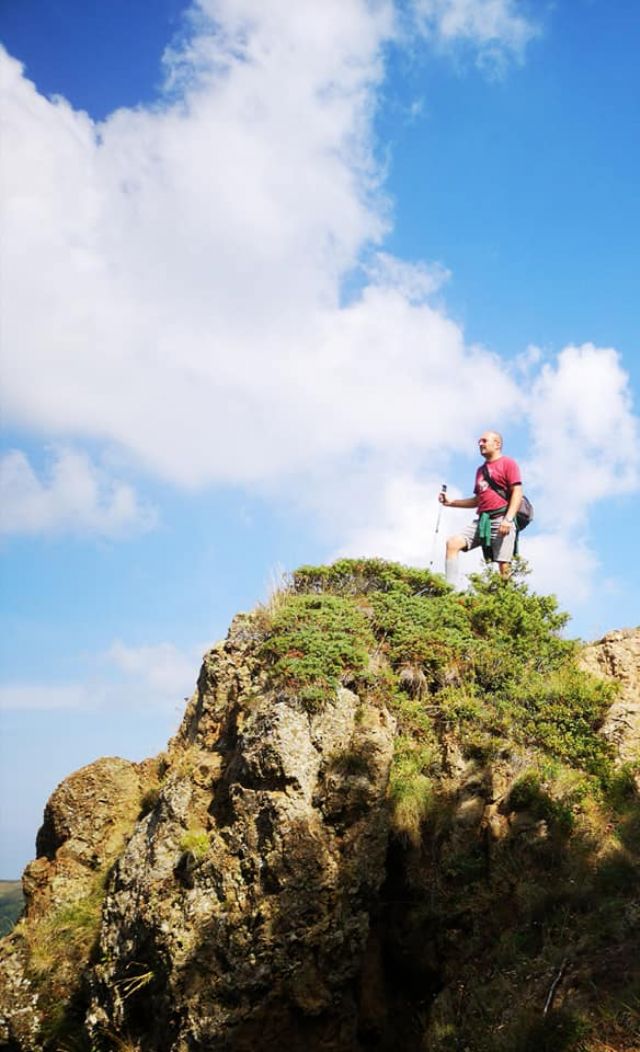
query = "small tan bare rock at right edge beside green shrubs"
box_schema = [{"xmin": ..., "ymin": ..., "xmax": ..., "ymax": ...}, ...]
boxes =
[{"xmin": 582, "ymin": 628, "xmax": 640, "ymax": 763}]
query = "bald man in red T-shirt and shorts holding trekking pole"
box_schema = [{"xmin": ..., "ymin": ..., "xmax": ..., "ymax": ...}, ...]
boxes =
[{"xmin": 439, "ymin": 431, "xmax": 522, "ymax": 585}]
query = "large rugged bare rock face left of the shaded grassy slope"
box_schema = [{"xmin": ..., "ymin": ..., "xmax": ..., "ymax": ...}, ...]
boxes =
[{"xmin": 88, "ymin": 618, "xmax": 394, "ymax": 1052}]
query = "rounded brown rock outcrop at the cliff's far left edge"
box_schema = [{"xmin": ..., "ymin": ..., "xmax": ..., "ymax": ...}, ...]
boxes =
[{"xmin": 0, "ymin": 757, "xmax": 149, "ymax": 1050}]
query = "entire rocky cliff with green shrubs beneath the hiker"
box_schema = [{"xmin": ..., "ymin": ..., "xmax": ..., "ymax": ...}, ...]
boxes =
[{"xmin": 0, "ymin": 561, "xmax": 640, "ymax": 1052}]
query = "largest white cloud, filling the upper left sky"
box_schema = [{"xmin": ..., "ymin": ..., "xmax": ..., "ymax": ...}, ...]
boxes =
[{"xmin": 0, "ymin": 0, "xmax": 530, "ymax": 500}]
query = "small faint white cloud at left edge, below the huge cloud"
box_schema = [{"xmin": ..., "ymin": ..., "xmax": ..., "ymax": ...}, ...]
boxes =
[{"xmin": 0, "ymin": 449, "xmax": 155, "ymax": 537}]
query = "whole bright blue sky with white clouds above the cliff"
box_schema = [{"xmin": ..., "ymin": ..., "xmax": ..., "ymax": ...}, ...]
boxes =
[{"xmin": 0, "ymin": 0, "xmax": 640, "ymax": 877}]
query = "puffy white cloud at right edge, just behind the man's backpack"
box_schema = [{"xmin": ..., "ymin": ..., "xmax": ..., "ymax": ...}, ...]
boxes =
[{"xmin": 503, "ymin": 343, "xmax": 640, "ymax": 605}]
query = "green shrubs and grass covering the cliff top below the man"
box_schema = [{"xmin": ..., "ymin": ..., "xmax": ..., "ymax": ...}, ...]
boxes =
[{"xmin": 261, "ymin": 560, "xmax": 615, "ymax": 836}]
